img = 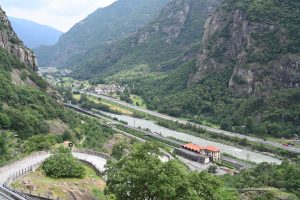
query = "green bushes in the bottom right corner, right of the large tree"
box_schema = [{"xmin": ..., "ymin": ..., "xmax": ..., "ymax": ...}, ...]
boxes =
[{"xmin": 222, "ymin": 162, "xmax": 300, "ymax": 200}]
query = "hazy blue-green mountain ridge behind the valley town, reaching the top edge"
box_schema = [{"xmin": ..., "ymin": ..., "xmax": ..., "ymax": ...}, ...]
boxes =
[{"xmin": 34, "ymin": 0, "xmax": 169, "ymax": 67}]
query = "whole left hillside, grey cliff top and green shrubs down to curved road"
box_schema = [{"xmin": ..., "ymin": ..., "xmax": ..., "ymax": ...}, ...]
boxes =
[{"xmin": 0, "ymin": 9, "xmax": 112, "ymax": 166}]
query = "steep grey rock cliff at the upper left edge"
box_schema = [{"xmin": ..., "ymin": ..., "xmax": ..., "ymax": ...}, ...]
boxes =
[{"xmin": 0, "ymin": 8, "xmax": 37, "ymax": 71}]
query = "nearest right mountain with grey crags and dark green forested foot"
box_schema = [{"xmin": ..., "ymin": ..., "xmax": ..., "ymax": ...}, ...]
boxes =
[{"xmin": 137, "ymin": 0, "xmax": 300, "ymax": 137}]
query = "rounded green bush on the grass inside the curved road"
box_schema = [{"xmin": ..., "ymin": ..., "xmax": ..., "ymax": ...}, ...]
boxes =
[{"xmin": 42, "ymin": 152, "xmax": 86, "ymax": 178}]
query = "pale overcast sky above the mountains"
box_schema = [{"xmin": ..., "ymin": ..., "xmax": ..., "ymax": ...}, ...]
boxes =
[{"xmin": 0, "ymin": 0, "xmax": 115, "ymax": 32}]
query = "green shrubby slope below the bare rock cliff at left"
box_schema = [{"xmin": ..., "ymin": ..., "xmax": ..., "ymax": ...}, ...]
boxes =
[{"xmin": 0, "ymin": 49, "xmax": 113, "ymax": 166}]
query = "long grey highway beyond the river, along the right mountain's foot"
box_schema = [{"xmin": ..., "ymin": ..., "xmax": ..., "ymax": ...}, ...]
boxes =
[{"xmin": 82, "ymin": 92, "xmax": 300, "ymax": 153}]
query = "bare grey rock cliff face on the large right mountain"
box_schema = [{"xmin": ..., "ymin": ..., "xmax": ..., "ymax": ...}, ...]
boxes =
[{"xmin": 189, "ymin": 3, "xmax": 300, "ymax": 95}]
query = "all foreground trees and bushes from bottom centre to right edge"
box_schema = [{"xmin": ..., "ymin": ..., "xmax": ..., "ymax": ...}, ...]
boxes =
[{"xmin": 105, "ymin": 142, "xmax": 300, "ymax": 200}]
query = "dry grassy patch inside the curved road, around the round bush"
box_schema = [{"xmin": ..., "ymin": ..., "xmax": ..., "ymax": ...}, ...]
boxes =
[{"xmin": 12, "ymin": 161, "xmax": 112, "ymax": 200}]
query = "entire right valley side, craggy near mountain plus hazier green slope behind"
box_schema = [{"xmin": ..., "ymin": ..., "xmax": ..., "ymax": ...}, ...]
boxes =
[{"xmin": 74, "ymin": 0, "xmax": 300, "ymax": 137}]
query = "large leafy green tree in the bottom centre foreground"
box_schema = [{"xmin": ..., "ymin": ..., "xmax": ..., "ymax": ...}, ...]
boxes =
[{"xmin": 106, "ymin": 143, "xmax": 236, "ymax": 200}]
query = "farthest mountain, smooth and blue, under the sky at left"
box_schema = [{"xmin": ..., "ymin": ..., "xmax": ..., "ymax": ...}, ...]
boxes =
[{"xmin": 9, "ymin": 17, "xmax": 63, "ymax": 48}]
